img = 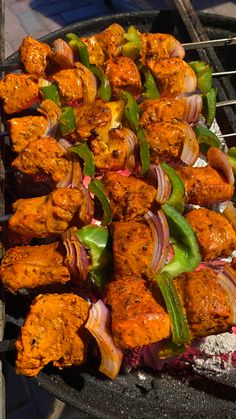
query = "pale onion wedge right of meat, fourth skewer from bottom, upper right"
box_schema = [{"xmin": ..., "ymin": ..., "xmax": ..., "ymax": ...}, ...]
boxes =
[{"xmin": 180, "ymin": 123, "xmax": 199, "ymax": 166}]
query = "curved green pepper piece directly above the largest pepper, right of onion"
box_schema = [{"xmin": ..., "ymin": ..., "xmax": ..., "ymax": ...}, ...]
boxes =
[{"xmin": 161, "ymin": 163, "xmax": 185, "ymax": 214}]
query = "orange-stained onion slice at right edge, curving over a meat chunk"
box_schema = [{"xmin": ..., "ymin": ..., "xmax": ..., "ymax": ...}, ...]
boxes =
[{"xmin": 207, "ymin": 147, "xmax": 234, "ymax": 185}]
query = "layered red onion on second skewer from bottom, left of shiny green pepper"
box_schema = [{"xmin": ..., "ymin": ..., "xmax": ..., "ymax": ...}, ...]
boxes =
[{"xmin": 62, "ymin": 227, "xmax": 89, "ymax": 281}]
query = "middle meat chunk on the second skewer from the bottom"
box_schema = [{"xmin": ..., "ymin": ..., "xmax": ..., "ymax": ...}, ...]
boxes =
[{"xmin": 112, "ymin": 221, "xmax": 154, "ymax": 279}]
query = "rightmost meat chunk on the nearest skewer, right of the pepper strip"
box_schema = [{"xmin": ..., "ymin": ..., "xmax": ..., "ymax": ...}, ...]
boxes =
[{"xmin": 174, "ymin": 268, "xmax": 232, "ymax": 339}]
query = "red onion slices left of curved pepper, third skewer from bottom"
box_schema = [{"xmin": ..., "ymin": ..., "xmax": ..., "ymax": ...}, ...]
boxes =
[{"xmin": 147, "ymin": 164, "xmax": 171, "ymax": 204}]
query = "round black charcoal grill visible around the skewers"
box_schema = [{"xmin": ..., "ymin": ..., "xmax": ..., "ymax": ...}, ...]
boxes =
[{"xmin": 1, "ymin": 5, "xmax": 236, "ymax": 419}]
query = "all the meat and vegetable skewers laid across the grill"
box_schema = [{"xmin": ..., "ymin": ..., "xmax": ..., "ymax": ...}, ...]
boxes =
[{"xmin": 0, "ymin": 24, "xmax": 236, "ymax": 379}]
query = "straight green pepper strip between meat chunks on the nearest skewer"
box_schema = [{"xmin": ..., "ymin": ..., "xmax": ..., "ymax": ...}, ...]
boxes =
[{"xmin": 155, "ymin": 272, "xmax": 191, "ymax": 348}]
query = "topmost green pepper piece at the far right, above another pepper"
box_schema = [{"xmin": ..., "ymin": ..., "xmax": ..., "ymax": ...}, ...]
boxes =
[{"xmin": 188, "ymin": 61, "xmax": 212, "ymax": 93}]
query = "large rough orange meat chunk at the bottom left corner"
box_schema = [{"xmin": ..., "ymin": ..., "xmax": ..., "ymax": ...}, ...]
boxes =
[{"xmin": 16, "ymin": 294, "xmax": 90, "ymax": 377}]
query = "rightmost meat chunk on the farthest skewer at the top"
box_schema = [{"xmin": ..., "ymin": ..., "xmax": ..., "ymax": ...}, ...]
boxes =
[{"xmin": 139, "ymin": 33, "xmax": 185, "ymax": 65}]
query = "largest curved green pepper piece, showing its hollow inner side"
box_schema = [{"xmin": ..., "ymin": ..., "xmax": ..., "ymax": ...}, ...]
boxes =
[{"xmin": 161, "ymin": 203, "xmax": 201, "ymax": 278}]
